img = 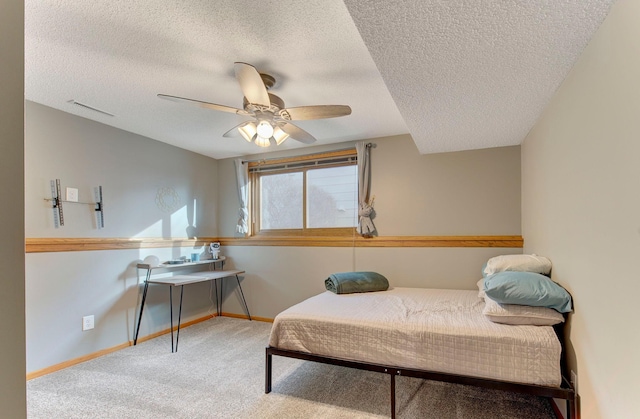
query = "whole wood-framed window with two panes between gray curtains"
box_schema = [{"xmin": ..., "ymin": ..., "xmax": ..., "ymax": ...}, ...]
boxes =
[{"xmin": 249, "ymin": 150, "xmax": 358, "ymax": 235}]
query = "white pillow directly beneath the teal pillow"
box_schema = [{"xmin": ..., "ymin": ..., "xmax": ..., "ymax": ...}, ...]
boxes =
[{"xmin": 482, "ymin": 296, "xmax": 564, "ymax": 326}]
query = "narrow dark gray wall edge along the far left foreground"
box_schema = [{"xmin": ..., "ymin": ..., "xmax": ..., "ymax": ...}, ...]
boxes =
[{"xmin": 0, "ymin": 0, "xmax": 27, "ymax": 418}]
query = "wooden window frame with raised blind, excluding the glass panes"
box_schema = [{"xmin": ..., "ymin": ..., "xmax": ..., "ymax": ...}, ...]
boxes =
[{"xmin": 249, "ymin": 148, "xmax": 357, "ymax": 237}]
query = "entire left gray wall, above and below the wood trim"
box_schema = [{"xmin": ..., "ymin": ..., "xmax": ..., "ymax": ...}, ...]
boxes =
[{"xmin": 24, "ymin": 102, "xmax": 218, "ymax": 372}]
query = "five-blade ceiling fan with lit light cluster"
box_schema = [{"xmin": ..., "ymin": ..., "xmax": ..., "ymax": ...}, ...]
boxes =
[{"xmin": 158, "ymin": 62, "xmax": 351, "ymax": 147}]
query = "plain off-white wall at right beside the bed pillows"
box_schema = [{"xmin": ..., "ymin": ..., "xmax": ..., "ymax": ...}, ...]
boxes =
[{"xmin": 522, "ymin": 0, "xmax": 640, "ymax": 419}]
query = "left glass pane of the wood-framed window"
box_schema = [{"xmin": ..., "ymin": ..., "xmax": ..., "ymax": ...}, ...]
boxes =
[{"xmin": 260, "ymin": 172, "xmax": 302, "ymax": 230}]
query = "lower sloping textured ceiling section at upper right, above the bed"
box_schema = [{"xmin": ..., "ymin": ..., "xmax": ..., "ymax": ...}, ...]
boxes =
[{"xmin": 345, "ymin": 0, "xmax": 614, "ymax": 153}]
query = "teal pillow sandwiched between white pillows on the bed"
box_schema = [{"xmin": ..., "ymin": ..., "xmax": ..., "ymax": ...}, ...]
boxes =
[{"xmin": 484, "ymin": 271, "xmax": 571, "ymax": 313}]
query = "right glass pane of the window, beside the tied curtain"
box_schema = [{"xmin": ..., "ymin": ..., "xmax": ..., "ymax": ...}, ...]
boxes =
[{"xmin": 307, "ymin": 165, "xmax": 358, "ymax": 228}]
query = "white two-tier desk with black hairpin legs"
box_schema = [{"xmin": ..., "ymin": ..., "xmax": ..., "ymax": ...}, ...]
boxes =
[{"xmin": 133, "ymin": 256, "xmax": 251, "ymax": 352}]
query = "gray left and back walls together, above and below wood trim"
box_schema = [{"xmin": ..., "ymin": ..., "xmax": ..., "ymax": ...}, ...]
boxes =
[{"xmin": 25, "ymin": 102, "xmax": 521, "ymax": 372}]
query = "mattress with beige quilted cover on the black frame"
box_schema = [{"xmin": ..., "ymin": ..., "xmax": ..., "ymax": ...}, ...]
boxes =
[{"xmin": 269, "ymin": 288, "xmax": 562, "ymax": 386}]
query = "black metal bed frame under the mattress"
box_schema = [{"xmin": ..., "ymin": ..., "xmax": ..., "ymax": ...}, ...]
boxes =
[{"xmin": 265, "ymin": 327, "xmax": 579, "ymax": 419}]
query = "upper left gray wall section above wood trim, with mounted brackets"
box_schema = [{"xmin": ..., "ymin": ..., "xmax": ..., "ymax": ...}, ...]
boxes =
[{"xmin": 25, "ymin": 102, "xmax": 217, "ymax": 238}]
